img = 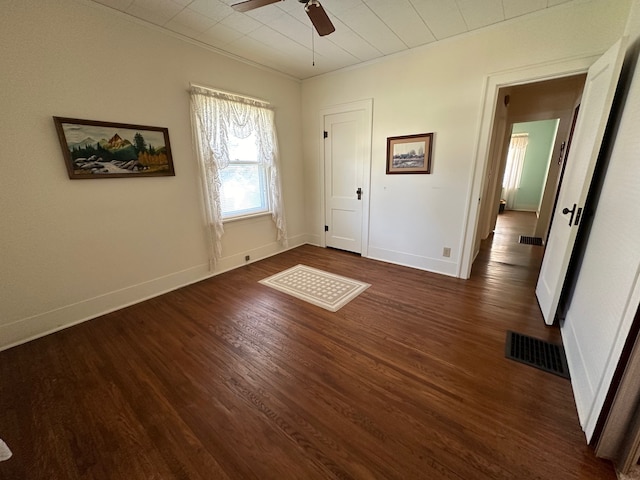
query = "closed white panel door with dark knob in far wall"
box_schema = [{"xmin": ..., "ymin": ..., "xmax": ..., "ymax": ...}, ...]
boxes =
[{"xmin": 324, "ymin": 110, "xmax": 370, "ymax": 253}]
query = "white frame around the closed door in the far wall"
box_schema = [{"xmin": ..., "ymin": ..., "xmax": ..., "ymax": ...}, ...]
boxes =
[{"xmin": 318, "ymin": 98, "xmax": 373, "ymax": 257}]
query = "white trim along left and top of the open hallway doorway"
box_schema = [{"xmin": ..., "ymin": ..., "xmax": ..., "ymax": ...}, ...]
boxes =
[{"xmin": 457, "ymin": 53, "xmax": 602, "ymax": 279}]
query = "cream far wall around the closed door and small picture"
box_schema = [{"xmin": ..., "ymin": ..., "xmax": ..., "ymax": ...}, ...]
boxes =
[{"xmin": 302, "ymin": 0, "xmax": 629, "ymax": 276}]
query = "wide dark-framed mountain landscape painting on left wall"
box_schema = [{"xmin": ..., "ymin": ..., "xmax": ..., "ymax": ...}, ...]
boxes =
[{"xmin": 53, "ymin": 117, "xmax": 175, "ymax": 179}]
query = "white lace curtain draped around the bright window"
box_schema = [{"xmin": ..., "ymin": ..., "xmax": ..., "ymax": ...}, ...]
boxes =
[{"xmin": 190, "ymin": 86, "xmax": 287, "ymax": 268}]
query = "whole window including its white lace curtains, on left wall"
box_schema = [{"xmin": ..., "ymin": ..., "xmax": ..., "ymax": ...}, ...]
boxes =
[{"xmin": 191, "ymin": 85, "xmax": 287, "ymax": 267}]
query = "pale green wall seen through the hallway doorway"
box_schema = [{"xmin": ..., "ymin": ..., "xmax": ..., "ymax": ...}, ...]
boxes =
[{"xmin": 511, "ymin": 119, "xmax": 559, "ymax": 212}]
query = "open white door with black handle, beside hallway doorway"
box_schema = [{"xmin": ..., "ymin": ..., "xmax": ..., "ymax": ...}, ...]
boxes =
[{"xmin": 536, "ymin": 38, "xmax": 626, "ymax": 325}]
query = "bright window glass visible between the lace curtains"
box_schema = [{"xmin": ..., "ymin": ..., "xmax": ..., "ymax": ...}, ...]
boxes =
[{"xmin": 220, "ymin": 133, "xmax": 269, "ymax": 219}]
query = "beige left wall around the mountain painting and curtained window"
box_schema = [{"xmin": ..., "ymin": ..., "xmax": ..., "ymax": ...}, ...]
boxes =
[{"xmin": 0, "ymin": 0, "xmax": 306, "ymax": 348}]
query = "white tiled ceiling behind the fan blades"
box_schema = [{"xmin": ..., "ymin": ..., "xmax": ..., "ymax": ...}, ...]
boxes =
[{"xmin": 92, "ymin": 0, "xmax": 580, "ymax": 79}]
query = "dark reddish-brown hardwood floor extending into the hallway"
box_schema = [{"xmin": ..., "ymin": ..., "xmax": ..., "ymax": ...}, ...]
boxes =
[{"xmin": 0, "ymin": 212, "xmax": 616, "ymax": 480}]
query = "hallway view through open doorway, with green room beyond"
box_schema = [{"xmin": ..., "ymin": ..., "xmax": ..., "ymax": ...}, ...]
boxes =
[{"xmin": 474, "ymin": 74, "xmax": 586, "ymax": 274}]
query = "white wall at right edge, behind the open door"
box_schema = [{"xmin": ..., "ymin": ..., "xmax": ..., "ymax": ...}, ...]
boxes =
[{"xmin": 562, "ymin": 38, "xmax": 640, "ymax": 442}]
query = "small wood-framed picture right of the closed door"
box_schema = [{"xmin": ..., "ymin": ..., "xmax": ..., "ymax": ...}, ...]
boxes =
[{"xmin": 387, "ymin": 133, "xmax": 433, "ymax": 174}]
